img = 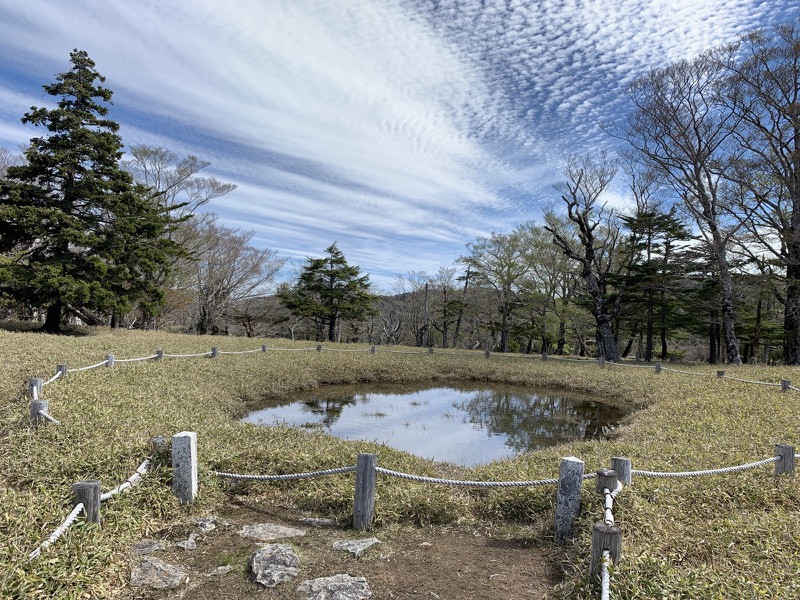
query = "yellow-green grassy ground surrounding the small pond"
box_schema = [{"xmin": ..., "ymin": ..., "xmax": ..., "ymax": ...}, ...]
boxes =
[{"xmin": 0, "ymin": 331, "xmax": 800, "ymax": 599}]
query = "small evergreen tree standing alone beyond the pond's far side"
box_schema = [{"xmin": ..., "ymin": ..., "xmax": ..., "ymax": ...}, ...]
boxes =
[{"xmin": 278, "ymin": 243, "xmax": 376, "ymax": 341}]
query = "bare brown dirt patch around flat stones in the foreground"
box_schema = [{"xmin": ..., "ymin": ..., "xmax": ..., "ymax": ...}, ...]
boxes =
[{"xmin": 128, "ymin": 494, "xmax": 563, "ymax": 600}]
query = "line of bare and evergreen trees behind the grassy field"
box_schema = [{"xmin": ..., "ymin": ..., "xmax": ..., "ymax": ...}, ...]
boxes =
[{"xmin": 0, "ymin": 22, "xmax": 800, "ymax": 364}]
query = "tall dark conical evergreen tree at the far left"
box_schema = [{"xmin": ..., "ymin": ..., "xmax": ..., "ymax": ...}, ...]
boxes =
[{"xmin": 0, "ymin": 50, "xmax": 175, "ymax": 332}]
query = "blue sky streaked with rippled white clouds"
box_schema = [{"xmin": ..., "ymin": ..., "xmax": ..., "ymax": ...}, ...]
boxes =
[{"xmin": 0, "ymin": 0, "xmax": 800, "ymax": 291}]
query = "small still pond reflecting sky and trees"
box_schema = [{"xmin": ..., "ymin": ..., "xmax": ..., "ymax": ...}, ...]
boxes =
[{"xmin": 243, "ymin": 384, "xmax": 626, "ymax": 466}]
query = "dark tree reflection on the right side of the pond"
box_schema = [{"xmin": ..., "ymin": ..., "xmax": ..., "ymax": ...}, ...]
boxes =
[{"xmin": 453, "ymin": 390, "xmax": 624, "ymax": 452}]
